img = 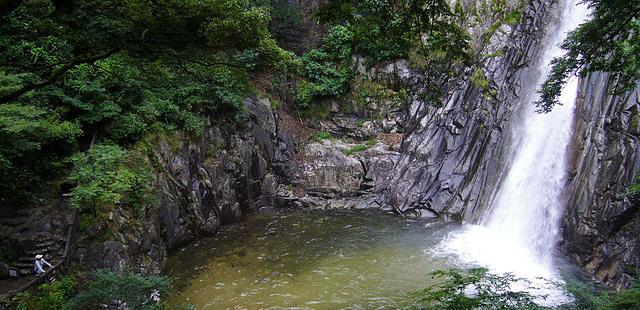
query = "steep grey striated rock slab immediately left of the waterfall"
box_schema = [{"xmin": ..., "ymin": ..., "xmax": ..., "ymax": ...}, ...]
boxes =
[{"xmin": 386, "ymin": 0, "xmax": 554, "ymax": 220}]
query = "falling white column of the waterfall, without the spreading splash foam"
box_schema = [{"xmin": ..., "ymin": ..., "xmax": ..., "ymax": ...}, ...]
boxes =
[{"xmin": 481, "ymin": 0, "xmax": 588, "ymax": 265}]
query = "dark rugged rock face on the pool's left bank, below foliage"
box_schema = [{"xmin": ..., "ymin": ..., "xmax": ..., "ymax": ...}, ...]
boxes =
[{"xmin": 76, "ymin": 99, "xmax": 289, "ymax": 273}]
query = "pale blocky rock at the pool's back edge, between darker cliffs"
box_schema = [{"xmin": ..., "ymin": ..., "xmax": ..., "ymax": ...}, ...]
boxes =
[{"xmin": 277, "ymin": 141, "xmax": 399, "ymax": 209}]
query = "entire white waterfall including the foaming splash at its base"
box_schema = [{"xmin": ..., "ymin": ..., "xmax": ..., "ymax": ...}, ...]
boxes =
[{"xmin": 439, "ymin": 0, "xmax": 588, "ymax": 302}]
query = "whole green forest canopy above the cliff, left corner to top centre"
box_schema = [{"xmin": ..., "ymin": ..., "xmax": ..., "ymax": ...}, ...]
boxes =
[{"xmin": 0, "ymin": 0, "xmax": 468, "ymax": 206}]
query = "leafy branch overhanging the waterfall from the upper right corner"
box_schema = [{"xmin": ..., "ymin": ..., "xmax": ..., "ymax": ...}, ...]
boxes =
[{"xmin": 536, "ymin": 0, "xmax": 640, "ymax": 112}]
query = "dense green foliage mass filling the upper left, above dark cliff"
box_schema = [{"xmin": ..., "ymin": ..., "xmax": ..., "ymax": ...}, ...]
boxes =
[{"xmin": 0, "ymin": 0, "xmax": 297, "ymax": 204}]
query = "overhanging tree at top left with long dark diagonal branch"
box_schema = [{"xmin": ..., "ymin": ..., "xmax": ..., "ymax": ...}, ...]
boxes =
[{"xmin": 0, "ymin": 0, "xmax": 292, "ymax": 102}]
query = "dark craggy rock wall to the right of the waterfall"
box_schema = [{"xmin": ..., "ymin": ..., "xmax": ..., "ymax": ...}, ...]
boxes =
[{"xmin": 562, "ymin": 73, "xmax": 640, "ymax": 288}]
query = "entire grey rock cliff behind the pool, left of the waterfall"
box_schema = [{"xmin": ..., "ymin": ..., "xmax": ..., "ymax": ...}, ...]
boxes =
[{"xmin": 77, "ymin": 0, "xmax": 554, "ymax": 272}]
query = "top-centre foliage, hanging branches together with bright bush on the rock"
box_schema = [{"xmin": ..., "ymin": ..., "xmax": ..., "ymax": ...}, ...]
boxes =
[{"xmin": 297, "ymin": 0, "xmax": 470, "ymax": 108}]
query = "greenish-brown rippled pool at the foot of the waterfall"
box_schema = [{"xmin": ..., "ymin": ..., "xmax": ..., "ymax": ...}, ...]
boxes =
[{"xmin": 165, "ymin": 209, "xmax": 592, "ymax": 309}]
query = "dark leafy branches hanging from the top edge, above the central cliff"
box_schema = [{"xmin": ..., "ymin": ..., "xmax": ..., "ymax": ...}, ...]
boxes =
[{"xmin": 319, "ymin": 0, "xmax": 468, "ymax": 62}]
